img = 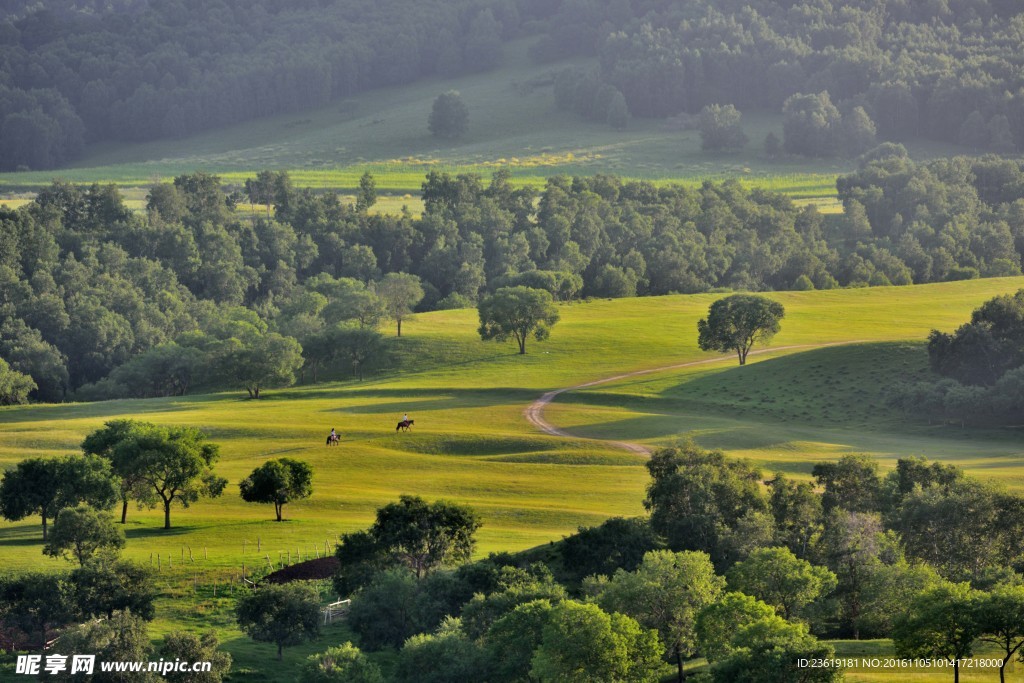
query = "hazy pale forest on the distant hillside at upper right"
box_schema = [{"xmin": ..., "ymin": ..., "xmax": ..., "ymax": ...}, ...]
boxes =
[{"xmin": 534, "ymin": 0, "xmax": 1024, "ymax": 156}]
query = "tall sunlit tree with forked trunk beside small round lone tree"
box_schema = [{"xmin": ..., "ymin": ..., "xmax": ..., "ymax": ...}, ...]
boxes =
[{"xmin": 107, "ymin": 424, "xmax": 227, "ymax": 528}]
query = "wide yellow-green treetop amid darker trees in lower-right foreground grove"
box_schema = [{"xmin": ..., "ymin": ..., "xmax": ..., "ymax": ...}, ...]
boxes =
[{"xmin": 728, "ymin": 548, "xmax": 836, "ymax": 621}]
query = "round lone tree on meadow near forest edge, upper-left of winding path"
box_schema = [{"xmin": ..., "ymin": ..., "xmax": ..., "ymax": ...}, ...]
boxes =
[{"xmin": 477, "ymin": 287, "xmax": 559, "ymax": 354}]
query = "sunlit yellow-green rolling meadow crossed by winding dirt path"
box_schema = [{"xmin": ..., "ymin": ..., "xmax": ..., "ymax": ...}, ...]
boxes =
[{"xmin": 0, "ymin": 278, "xmax": 1024, "ymax": 681}]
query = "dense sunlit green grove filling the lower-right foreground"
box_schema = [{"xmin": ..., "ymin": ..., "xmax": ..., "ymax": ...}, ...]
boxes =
[{"xmin": 311, "ymin": 443, "xmax": 1024, "ymax": 682}]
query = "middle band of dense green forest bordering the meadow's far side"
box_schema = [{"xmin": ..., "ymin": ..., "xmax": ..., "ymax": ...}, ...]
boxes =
[{"xmin": 0, "ymin": 160, "xmax": 1024, "ymax": 402}]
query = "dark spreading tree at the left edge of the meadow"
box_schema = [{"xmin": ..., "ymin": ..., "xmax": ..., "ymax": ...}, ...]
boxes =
[{"xmin": 0, "ymin": 456, "xmax": 118, "ymax": 541}]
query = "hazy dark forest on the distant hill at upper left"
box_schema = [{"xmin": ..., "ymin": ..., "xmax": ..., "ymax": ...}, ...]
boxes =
[{"xmin": 0, "ymin": 0, "xmax": 532, "ymax": 170}]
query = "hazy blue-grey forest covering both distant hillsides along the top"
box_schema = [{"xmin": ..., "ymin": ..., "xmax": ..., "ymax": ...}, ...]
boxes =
[{"xmin": 0, "ymin": 0, "xmax": 1024, "ymax": 169}]
